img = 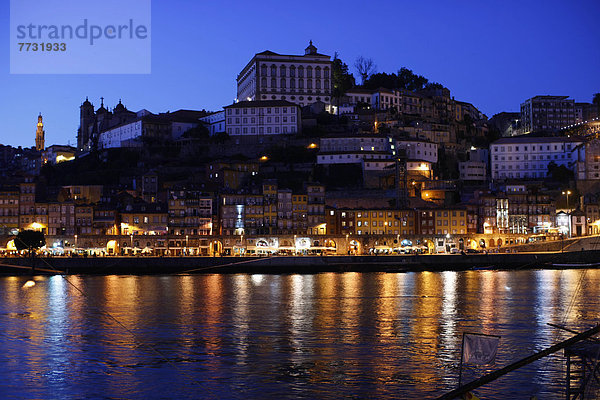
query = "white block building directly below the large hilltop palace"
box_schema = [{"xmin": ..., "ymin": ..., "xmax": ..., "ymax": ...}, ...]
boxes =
[{"xmin": 224, "ymin": 100, "xmax": 302, "ymax": 136}]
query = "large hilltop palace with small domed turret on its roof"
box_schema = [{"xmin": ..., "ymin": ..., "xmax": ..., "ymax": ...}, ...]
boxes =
[{"xmin": 237, "ymin": 41, "xmax": 333, "ymax": 106}]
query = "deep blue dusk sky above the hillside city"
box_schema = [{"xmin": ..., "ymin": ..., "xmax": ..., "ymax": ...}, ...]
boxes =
[{"xmin": 0, "ymin": 0, "xmax": 600, "ymax": 147}]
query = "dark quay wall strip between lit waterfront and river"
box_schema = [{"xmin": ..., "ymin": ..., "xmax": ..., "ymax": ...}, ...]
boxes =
[{"xmin": 0, "ymin": 250, "xmax": 600, "ymax": 275}]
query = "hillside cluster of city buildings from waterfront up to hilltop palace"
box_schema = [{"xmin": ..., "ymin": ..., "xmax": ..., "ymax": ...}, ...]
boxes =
[{"xmin": 0, "ymin": 42, "xmax": 600, "ymax": 255}]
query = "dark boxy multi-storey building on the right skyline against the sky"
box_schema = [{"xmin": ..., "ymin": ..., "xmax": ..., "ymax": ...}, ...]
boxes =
[{"xmin": 521, "ymin": 96, "xmax": 576, "ymax": 134}]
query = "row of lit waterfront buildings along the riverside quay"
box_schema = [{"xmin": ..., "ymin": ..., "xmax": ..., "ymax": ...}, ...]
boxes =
[{"xmin": 0, "ymin": 175, "xmax": 600, "ymax": 244}]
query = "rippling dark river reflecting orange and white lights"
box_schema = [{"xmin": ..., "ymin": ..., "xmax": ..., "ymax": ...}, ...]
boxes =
[{"xmin": 0, "ymin": 270, "xmax": 600, "ymax": 399}]
